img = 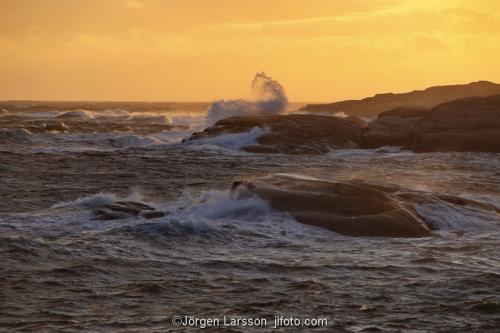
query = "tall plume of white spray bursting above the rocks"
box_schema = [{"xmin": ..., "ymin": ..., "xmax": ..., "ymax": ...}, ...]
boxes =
[{"xmin": 207, "ymin": 72, "xmax": 288, "ymax": 125}]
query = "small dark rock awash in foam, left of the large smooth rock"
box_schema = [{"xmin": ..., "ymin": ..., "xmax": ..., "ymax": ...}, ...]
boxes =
[{"xmin": 93, "ymin": 201, "xmax": 165, "ymax": 220}]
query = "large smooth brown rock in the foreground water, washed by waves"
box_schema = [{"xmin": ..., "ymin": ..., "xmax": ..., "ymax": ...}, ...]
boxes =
[{"xmin": 232, "ymin": 176, "xmax": 431, "ymax": 237}]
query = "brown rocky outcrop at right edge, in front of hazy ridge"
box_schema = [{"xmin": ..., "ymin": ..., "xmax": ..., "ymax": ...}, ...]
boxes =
[{"xmin": 363, "ymin": 95, "xmax": 500, "ymax": 152}]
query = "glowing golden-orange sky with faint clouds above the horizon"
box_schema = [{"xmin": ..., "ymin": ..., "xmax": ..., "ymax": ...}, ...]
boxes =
[{"xmin": 0, "ymin": 0, "xmax": 500, "ymax": 101}]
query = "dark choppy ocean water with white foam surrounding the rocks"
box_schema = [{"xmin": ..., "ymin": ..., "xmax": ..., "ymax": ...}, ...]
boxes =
[{"xmin": 0, "ymin": 103, "xmax": 500, "ymax": 332}]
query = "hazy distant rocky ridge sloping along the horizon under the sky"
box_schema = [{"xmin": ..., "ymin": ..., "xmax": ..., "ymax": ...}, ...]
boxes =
[{"xmin": 301, "ymin": 81, "xmax": 500, "ymax": 117}]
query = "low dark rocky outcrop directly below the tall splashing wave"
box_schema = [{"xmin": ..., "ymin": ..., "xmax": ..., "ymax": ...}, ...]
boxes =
[{"xmin": 187, "ymin": 114, "xmax": 366, "ymax": 154}]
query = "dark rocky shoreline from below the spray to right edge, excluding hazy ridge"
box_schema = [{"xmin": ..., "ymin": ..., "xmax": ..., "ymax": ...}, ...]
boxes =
[{"xmin": 186, "ymin": 95, "xmax": 500, "ymax": 154}]
